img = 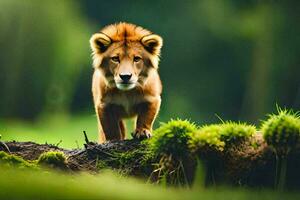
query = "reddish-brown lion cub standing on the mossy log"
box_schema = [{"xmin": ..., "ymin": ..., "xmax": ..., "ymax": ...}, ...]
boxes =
[{"xmin": 90, "ymin": 23, "xmax": 163, "ymax": 143}]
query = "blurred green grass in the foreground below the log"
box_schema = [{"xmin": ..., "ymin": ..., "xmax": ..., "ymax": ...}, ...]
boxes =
[{"xmin": 0, "ymin": 167, "xmax": 300, "ymax": 200}]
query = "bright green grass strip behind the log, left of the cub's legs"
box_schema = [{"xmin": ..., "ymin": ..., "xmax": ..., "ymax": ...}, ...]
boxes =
[{"xmin": 0, "ymin": 114, "xmax": 133, "ymax": 148}]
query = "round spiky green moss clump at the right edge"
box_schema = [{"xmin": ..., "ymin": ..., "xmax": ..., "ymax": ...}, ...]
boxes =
[{"xmin": 261, "ymin": 109, "xmax": 300, "ymax": 153}]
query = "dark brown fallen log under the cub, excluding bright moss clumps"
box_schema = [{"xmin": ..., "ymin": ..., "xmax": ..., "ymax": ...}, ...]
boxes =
[{"xmin": 0, "ymin": 134, "xmax": 300, "ymax": 188}]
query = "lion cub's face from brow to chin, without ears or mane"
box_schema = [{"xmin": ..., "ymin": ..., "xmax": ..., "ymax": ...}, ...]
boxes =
[{"xmin": 96, "ymin": 42, "xmax": 151, "ymax": 90}]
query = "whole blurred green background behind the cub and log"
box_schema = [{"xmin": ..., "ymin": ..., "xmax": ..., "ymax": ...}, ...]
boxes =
[{"xmin": 0, "ymin": 0, "xmax": 300, "ymax": 148}]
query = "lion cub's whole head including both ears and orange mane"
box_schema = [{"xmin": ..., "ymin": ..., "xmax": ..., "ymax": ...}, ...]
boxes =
[{"xmin": 90, "ymin": 23, "xmax": 162, "ymax": 90}]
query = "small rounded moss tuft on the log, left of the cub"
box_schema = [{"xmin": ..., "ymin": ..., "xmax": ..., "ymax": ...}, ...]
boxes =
[{"xmin": 37, "ymin": 151, "xmax": 67, "ymax": 169}]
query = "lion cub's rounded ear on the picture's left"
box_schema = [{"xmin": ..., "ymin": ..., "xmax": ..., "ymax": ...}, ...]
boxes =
[{"xmin": 90, "ymin": 33, "xmax": 112, "ymax": 53}]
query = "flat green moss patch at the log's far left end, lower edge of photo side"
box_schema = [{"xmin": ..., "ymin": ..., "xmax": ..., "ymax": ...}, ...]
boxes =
[{"xmin": 0, "ymin": 151, "xmax": 38, "ymax": 169}]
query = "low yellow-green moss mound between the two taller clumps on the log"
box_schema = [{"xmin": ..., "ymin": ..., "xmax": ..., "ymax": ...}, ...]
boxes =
[{"xmin": 189, "ymin": 122, "xmax": 256, "ymax": 152}]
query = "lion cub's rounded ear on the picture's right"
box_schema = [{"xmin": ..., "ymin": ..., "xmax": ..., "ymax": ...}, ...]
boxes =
[{"xmin": 141, "ymin": 34, "xmax": 163, "ymax": 56}]
